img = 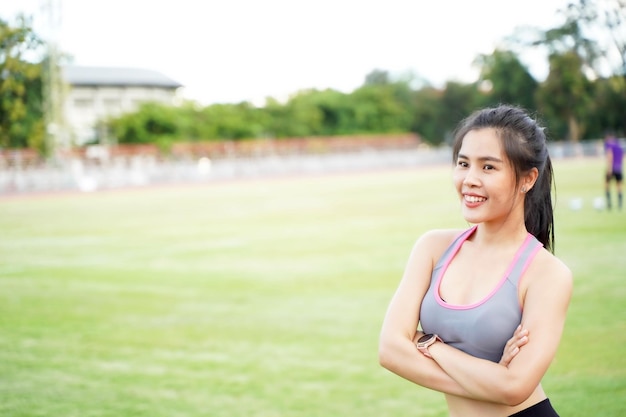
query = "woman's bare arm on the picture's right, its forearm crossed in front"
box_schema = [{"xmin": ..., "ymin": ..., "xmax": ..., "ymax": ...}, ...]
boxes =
[{"xmin": 429, "ymin": 252, "xmax": 572, "ymax": 405}]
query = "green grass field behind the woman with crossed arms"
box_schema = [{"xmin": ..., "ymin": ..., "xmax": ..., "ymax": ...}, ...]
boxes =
[{"xmin": 0, "ymin": 159, "xmax": 626, "ymax": 417}]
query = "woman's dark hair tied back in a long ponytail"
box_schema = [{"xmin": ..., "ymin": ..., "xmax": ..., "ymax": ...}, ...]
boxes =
[{"xmin": 452, "ymin": 105, "xmax": 554, "ymax": 252}]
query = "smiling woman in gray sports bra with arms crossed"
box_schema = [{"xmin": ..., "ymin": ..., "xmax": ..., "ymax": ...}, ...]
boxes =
[{"xmin": 379, "ymin": 106, "xmax": 572, "ymax": 417}]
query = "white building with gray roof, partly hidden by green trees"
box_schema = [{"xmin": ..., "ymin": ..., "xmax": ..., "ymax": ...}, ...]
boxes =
[{"xmin": 61, "ymin": 65, "xmax": 182, "ymax": 145}]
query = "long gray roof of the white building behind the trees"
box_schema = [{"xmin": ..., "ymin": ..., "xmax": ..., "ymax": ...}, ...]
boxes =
[{"xmin": 61, "ymin": 65, "xmax": 182, "ymax": 88}]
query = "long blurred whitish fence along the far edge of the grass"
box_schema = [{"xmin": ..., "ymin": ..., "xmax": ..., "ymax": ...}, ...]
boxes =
[{"xmin": 0, "ymin": 141, "xmax": 603, "ymax": 195}]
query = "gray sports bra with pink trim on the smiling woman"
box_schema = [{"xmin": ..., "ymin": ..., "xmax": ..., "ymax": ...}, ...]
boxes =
[{"xmin": 420, "ymin": 226, "xmax": 543, "ymax": 362}]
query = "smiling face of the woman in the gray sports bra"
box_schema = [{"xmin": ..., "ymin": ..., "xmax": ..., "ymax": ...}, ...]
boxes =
[{"xmin": 454, "ymin": 128, "xmax": 523, "ymax": 223}]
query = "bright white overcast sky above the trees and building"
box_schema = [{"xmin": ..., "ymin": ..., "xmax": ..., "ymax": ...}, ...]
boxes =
[{"xmin": 0, "ymin": 0, "xmax": 567, "ymax": 105}]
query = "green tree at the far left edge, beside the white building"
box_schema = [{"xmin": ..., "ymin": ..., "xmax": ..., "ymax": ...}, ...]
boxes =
[{"xmin": 0, "ymin": 16, "xmax": 45, "ymax": 150}]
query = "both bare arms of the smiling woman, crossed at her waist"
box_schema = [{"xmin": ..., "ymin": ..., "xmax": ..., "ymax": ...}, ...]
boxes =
[{"xmin": 379, "ymin": 229, "xmax": 571, "ymax": 405}]
